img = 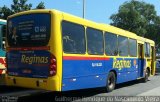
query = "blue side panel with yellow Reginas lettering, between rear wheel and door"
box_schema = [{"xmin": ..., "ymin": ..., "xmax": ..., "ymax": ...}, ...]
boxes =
[{"xmin": 112, "ymin": 58, "xmax": 138, "ymax": 84}]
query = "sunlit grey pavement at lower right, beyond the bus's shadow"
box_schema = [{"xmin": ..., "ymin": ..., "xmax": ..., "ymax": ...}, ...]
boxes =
[{"xmin": 98, "ymin": 75, "xmax": 160, "ymax": 96}]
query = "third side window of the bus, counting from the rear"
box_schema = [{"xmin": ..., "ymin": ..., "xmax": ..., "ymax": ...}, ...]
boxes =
[{"xmin": 105, "ymin": 33, "xmax": 118, "ymax": 56}]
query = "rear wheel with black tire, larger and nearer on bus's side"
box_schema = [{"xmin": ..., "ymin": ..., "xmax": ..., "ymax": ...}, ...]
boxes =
[{"xmin": 106, "ymin": 72, "xmax": 116, "ymax": 92}]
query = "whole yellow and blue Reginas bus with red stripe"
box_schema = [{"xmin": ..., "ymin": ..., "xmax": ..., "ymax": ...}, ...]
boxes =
[{"xmin": 6, "ymin": 10, "xmax": 155, "ymax": 92}]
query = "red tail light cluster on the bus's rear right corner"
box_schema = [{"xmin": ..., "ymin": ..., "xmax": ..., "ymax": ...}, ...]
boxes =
[{"xmin": 49, "ymin": 55, "xmax": 57, "ymax": 76}]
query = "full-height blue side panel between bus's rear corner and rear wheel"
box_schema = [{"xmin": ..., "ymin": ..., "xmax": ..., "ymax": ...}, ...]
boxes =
[{"xmin": 62, "ymin": 59, "xmax": 109, "ymax": 91}]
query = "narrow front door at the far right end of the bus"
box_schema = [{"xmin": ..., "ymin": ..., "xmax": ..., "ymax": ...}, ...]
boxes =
[{"xmin": 151, "ymin": 46, "xmax": 155, "ymax": 75}]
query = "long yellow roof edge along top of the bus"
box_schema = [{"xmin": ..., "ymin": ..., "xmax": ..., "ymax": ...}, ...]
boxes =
[{"xmin": 8, "ymin": 9, "xmax": 154, "ymax": 44}]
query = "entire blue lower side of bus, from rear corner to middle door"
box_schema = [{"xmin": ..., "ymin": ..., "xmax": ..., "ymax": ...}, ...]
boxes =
[{"xmin": 62, "ymin": 58, "xmax": 144, "ymax": 91}]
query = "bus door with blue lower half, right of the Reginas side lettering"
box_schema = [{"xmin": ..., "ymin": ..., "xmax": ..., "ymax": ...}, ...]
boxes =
[{"xmin": 138, "ymin": 44, "xmax": 144, "ymax": 77}]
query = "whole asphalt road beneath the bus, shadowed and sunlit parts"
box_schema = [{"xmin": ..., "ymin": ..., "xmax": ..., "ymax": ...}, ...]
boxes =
[{"xmin": 0, "ymin": 75, "xmax": 160, "ymax": 102}]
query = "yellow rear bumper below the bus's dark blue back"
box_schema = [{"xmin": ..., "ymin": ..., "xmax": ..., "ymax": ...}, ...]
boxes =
[{"xmin": 5, "ymin": 75, "xmax": 61, "ymax": 91}]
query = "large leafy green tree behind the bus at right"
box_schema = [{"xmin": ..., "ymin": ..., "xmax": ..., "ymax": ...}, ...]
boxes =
[{"xmin": 110, "ymin": 0, "xmax": 160, "ymax": 47}]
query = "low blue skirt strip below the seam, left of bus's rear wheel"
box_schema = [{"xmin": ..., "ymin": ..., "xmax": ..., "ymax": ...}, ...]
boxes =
[{"xmin": 62, "ymin": 74, "xmax": 106, "ymax": 91}]
